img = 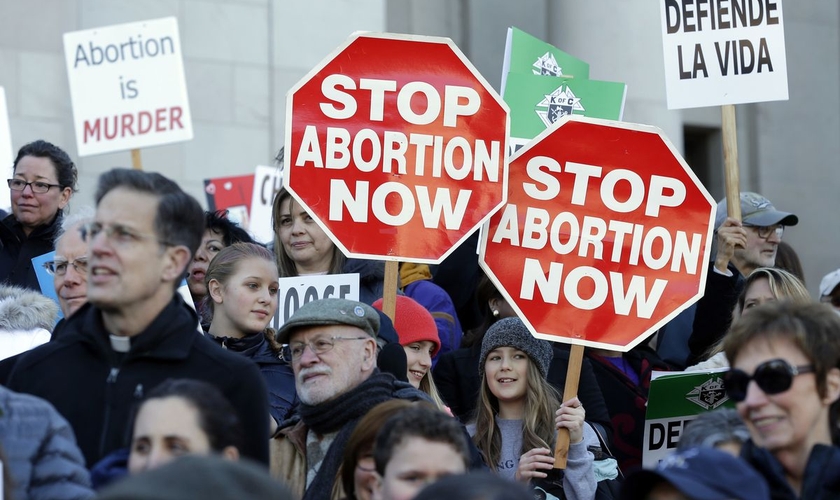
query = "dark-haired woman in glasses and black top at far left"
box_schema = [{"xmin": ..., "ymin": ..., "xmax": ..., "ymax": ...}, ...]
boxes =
[{"xmin": 0, "ymin": 140, "xmax": 78, "ymax": 292}]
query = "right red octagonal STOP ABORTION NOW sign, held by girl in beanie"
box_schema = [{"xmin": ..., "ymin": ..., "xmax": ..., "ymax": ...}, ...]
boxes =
[{"xmin": 480, "ymin": 117, "xmax": 715, "ymax": 351}]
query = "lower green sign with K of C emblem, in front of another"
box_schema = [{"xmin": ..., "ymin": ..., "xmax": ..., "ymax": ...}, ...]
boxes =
[{"xmin": 503, "ymin": 73, "xmax": 627, "ymax": 151}]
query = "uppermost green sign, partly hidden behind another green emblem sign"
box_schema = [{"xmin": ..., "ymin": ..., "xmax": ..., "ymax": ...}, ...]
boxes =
[{"xmin": 501, "ymin": 28, "xmax": 589, "ymax": 94}]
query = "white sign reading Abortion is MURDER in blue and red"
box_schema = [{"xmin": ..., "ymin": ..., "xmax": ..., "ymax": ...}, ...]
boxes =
[{"xmin": 64, "ymin": 17, "xmax": 193, "ymax": 156}]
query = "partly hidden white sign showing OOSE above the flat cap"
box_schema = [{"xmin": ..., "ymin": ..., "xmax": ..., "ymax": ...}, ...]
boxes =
[{"xmin": 271, "ymin": 273, "xmax": 359, "ymax": 329}]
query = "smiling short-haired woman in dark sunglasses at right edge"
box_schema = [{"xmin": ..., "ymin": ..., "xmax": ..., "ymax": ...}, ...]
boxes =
[{"xmin": 724, "ymin": 302, "xmax": 840, "ymax": 500}]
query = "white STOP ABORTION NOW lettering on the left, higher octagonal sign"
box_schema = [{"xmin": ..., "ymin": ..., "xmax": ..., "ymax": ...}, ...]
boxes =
[{"xmin": 293, "ymin": 74, "xmax": 504, "ymax": 230}]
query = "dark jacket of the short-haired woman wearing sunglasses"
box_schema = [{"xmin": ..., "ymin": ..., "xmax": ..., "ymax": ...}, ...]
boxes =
[{"xmin": 741, "ymin": 440, "xmax": 840, "ymax": 500}]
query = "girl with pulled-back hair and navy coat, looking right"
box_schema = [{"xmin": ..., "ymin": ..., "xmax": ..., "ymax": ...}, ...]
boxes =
[{"xmin": 205, "ymin": 243, "xmax": 297, "ymax": 423}]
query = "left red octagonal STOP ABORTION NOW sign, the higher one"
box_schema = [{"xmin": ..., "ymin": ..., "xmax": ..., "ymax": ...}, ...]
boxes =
[{"xmin": 284, "ymin": 33, "xmax": 509, "ymax": 263}]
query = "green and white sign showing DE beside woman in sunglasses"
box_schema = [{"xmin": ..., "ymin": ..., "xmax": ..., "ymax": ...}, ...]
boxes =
[{"xmin": 642, "ymin": 369, "xmax": 735, "ymax": 468}]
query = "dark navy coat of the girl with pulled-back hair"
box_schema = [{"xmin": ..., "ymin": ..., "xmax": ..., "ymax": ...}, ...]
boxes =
[{"xmin": 208, "ymin": 332, "xmax": 298, "ymax": 423}]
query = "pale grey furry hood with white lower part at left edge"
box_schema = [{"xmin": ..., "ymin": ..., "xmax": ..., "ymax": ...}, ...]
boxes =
[{"xmin": 0, "ymin": 286, "xmax": 58, "ymax": 359}]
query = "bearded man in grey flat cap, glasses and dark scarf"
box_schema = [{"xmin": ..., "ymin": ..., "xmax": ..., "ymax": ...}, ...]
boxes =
[{"xmin": 270, "ymin": 299, "xmax": 429, "ymax": 499}]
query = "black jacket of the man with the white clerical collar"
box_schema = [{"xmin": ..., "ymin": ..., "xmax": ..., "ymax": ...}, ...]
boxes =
[{"xmin": 8, "ymin": 294, "xmax": 269, "ymax": 466}]
